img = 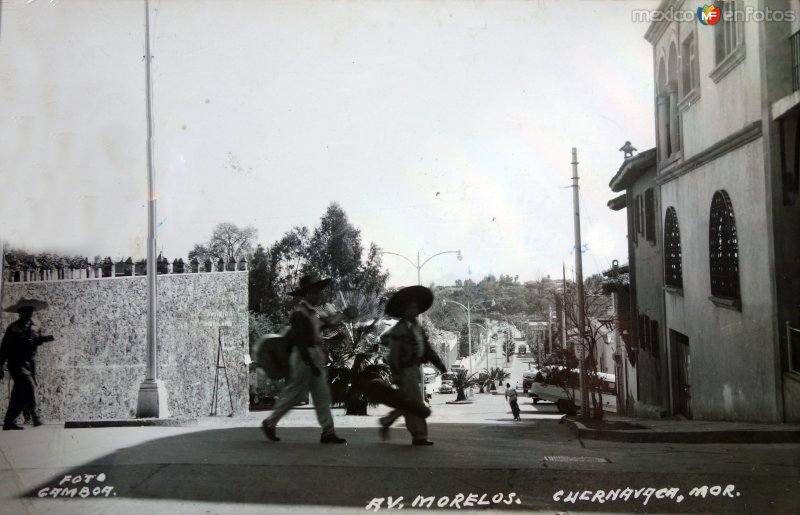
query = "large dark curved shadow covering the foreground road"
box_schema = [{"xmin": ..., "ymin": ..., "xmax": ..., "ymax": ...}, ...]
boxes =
[{"xmin": 25, "ymin": 420, "xmax": 790, "ymax": 513}]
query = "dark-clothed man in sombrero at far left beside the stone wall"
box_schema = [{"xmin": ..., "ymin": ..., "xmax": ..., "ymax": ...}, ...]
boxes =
[{"xmin": 0, "ymin": 299, "xmax": 53, "ymax": 431}]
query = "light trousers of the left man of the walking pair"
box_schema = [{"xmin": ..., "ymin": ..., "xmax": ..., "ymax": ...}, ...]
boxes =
[{"xmin": 266, "ymin": 345, "xmax": 334, "ymax": 435}]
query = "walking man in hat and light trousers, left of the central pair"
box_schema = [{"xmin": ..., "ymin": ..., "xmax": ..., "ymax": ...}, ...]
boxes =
[{"xmin": 261, "ymin": 275, "xmax": 346, "ymax": 443}]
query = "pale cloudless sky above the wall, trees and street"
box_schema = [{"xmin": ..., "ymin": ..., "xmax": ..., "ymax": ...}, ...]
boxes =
[{"xmin": 0, "ymin": 0, "xmax": 657, "ymax": 286}]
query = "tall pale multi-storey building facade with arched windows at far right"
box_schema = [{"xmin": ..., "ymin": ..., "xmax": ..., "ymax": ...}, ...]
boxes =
[{"xmin": 632, "ymin": 0, "xmax": 800, "ymax": 422}]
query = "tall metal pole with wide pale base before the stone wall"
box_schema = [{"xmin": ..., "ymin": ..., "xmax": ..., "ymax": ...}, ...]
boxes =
[{"xmin": 136, "ymin": 0, "xmax": 169, "ymax": 418}]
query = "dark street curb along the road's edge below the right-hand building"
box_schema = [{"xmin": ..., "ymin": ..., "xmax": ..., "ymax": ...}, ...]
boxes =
[{"xmin": 564, "ymin": 418, "xmax": 800, "ymax": 444}]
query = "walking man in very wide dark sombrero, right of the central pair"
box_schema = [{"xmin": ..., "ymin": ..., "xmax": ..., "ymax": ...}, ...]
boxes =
[{"xmin": 380, "ymin": 286, "xmax": 447, "ymax": 445}]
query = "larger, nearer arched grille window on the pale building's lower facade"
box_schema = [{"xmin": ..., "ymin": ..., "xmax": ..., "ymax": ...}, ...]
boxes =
[{"xmin": 708, "ymin": 190, "xmax": 740, "ymax": 299}]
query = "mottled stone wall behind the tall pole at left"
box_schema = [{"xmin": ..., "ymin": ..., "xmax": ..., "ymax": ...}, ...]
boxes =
[{"xmin": 0, "ymin": 272, "xmax": 248, "ymax": 421}]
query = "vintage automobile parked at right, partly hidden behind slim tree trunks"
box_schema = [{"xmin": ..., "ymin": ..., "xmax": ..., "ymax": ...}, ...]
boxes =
[{"xmin": 531, "ymin": 367, "xmax": 617, "ymax": 414}]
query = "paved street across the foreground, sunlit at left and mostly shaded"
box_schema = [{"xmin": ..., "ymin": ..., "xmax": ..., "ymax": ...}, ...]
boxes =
[{"xmin": 0, "ymin": 395, "xmax": 800, "ymax": 514}]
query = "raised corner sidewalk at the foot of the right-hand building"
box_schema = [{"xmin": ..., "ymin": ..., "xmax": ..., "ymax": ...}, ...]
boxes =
[{"xmin": 564, "ymin": 413, "xmax": 800, "ymax": 443}]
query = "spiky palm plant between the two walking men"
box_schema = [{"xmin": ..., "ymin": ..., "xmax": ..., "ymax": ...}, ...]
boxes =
[{"xmin": 329, "ymin": 291, "xmax": 390, "ymax": 415}]
